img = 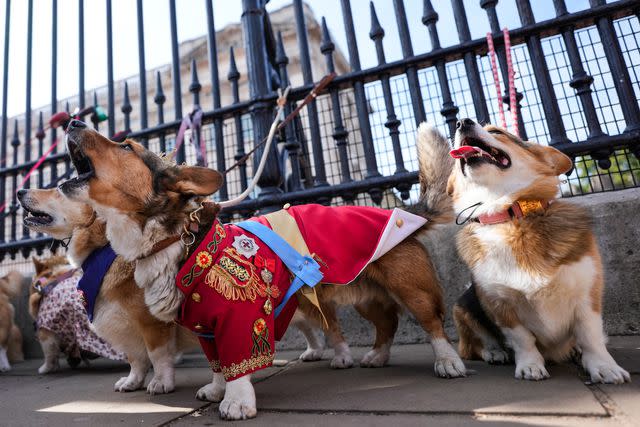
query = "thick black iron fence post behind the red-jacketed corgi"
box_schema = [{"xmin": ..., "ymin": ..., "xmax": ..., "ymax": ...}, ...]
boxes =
[{"xmin": 242, "ymin": 0, "xmax": 282, "ymax": 212}]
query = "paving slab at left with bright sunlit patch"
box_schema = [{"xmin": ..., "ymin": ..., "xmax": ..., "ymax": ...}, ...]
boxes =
[{"xmin": 0, "ymin": 356, "xmax": 280, "ymax": 426}]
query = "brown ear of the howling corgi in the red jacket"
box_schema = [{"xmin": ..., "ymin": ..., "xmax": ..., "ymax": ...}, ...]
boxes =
[{"xmin": 162, "ymin": 166, "xmax": 223, "ymax": 196}]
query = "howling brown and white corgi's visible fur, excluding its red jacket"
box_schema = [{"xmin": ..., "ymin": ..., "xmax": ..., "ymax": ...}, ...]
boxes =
[{"xmin": 60, "ymin": 121, "xmax": 465, "ymax": 419}]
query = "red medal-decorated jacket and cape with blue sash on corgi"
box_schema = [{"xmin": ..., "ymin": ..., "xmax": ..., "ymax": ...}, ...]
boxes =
[{"xmin": 176, "ymin": 205, "xmax": 426, "ymax": 381}]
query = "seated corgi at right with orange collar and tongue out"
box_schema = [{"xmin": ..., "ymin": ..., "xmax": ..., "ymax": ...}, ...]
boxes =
[{"xmin": 440, "ymin": 119, "xmax": 629, "ymax": 383}]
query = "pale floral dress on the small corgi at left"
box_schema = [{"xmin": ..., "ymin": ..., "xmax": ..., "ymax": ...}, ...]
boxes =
[{"xmin": 36, "ymin": 274, "xmax": 127, "ymax": 361}]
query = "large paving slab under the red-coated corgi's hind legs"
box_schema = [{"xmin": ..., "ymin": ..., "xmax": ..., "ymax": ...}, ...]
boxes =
[{"xmin": 256, "ymin": 345, "xmax": 606, "ymax": 416}]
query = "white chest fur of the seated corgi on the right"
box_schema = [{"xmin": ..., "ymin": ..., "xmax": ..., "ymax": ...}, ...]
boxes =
[{"xmin": 473, "ymin": 227, "xmax": 597, "ymax": 343}]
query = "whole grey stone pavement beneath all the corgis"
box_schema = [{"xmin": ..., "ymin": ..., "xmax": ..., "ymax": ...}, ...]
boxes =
[{"xmin": 0, "ymin": 336, "xmax": 640, "ymax": 427}]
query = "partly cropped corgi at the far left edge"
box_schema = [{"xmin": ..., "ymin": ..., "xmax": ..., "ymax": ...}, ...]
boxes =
[{"xmin": 0, "ymin": 271, "xmax": 24, "ymax": 372}]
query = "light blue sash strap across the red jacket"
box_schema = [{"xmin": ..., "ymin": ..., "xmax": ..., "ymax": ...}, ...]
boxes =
[{"xmin": 235, "ymin": 221, "xmax": 323, "ymax": 317}]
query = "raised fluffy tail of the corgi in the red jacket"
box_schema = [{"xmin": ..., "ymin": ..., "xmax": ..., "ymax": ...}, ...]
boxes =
[{"xmin": 411, "ymin": 123, "xmax": 453, "ymax": 225}]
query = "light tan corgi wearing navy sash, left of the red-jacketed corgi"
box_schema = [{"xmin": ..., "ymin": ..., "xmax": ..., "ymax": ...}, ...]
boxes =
[{"xmin": 18, "ymin": 188, "xmax": 197, "ymax": 394}]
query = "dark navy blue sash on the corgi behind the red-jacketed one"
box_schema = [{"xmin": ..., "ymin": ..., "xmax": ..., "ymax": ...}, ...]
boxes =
[{"xmin": 78, "ymin": 245, "xmax": 116, "ymax": 322}]
